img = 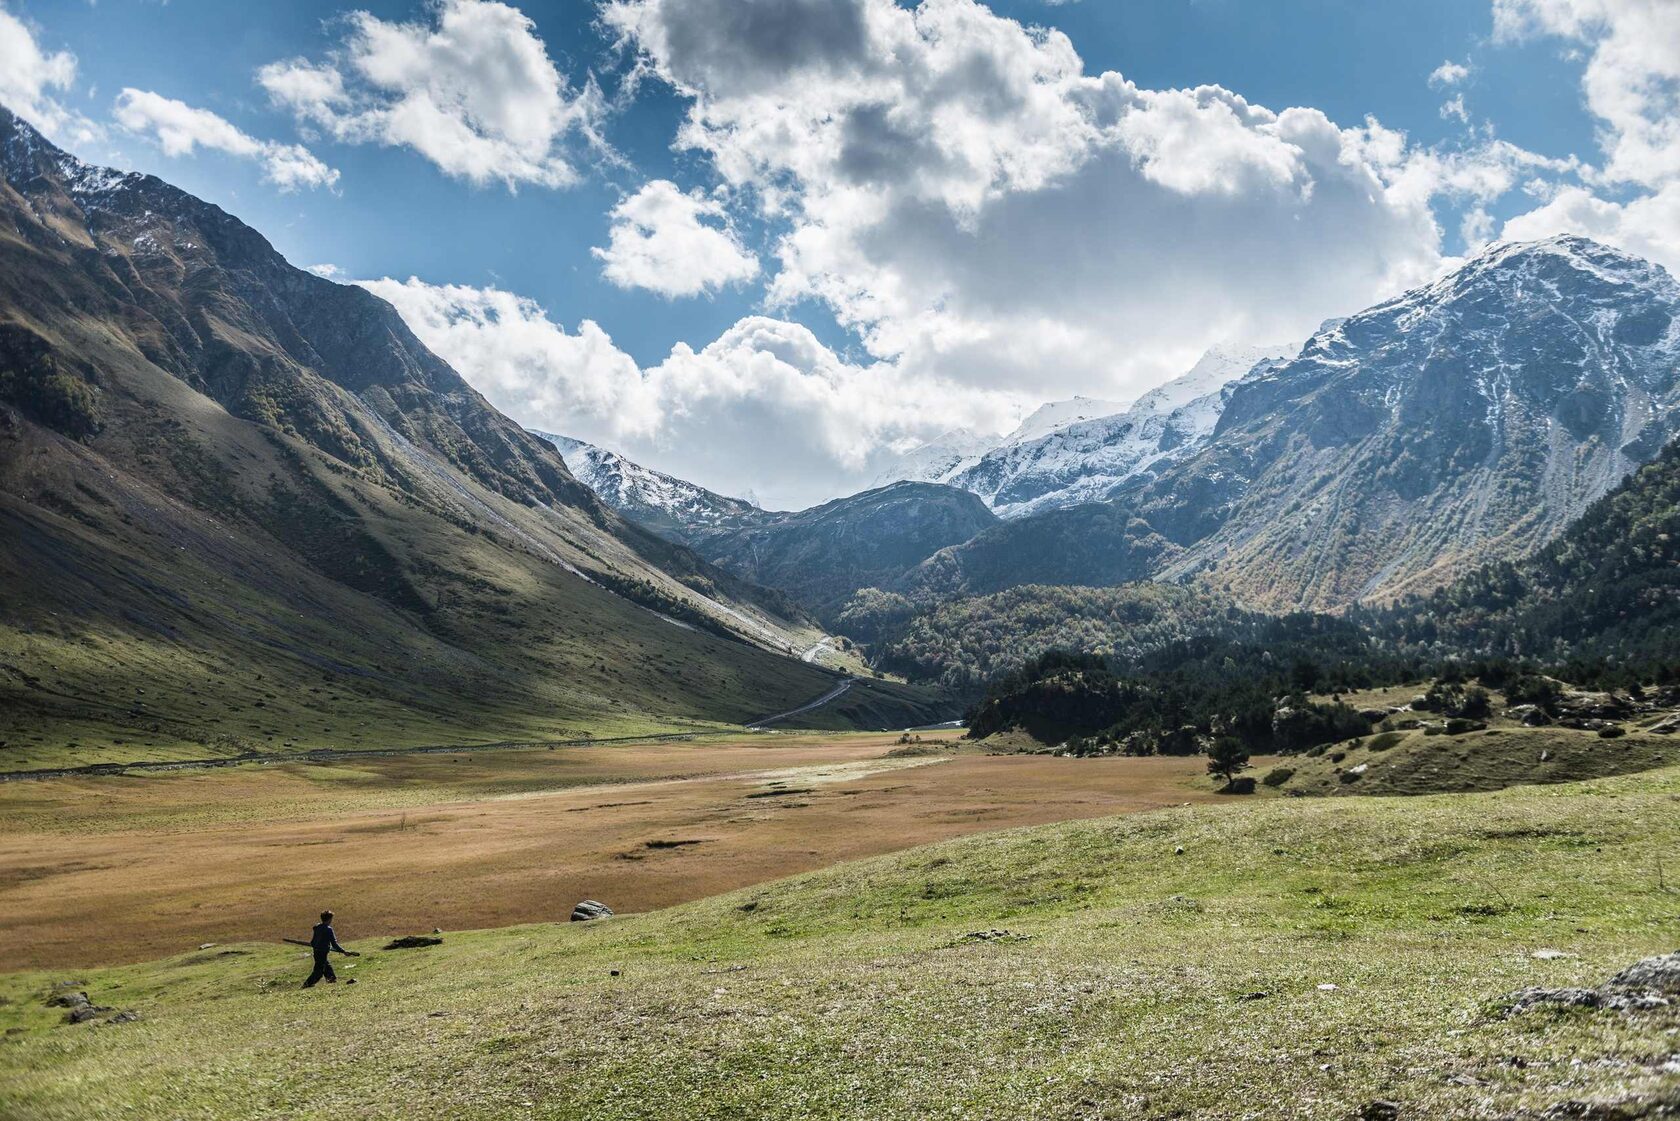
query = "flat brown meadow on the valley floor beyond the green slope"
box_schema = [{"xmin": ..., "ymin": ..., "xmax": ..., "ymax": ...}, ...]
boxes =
[{"xmin": 0, "ymin": 734, "xmax": 1236, "ymax": 970}]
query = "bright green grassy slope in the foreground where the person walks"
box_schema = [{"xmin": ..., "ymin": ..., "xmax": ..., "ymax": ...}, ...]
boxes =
[{"xmin": 0, "ymin": 763, "xmax": 1680, "ymax": 1121}]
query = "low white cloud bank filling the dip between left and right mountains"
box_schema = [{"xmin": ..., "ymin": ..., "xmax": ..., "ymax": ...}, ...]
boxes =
[{"xmin": 363, "ymin": 279, "xmax": 1025, "ymax": 508}]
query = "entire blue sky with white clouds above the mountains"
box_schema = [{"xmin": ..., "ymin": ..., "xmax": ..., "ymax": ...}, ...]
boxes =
[{"xmin": 0, "ymin": 0, "xmax": 1680, "ymax": 508}]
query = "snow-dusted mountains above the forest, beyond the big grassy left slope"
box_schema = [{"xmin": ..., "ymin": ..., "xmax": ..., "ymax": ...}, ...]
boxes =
[{"xmin": 554, "ymin": 237, "xmax": 1680, "ymax": 631}]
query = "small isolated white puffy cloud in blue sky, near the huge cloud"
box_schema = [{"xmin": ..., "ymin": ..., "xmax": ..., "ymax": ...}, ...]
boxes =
[{"xmin": 593, "ymin": 180, "xmax": 758, "ymax": 296}]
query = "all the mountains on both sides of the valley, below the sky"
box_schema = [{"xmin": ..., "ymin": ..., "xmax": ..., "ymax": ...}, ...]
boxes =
[{"xmin": 0, "ymin": 94, "xmax": 1680, "ymax": 760}]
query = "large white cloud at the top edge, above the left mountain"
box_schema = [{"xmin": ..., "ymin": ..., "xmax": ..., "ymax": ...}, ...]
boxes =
[{"xmin": 257, "ymin": 0, "xmax": 601, "ymax": 188}]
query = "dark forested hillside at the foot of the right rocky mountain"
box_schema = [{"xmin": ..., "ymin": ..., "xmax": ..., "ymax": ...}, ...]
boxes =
[{"xmin": 840, "ymin": 433, "xmax": 1680, "ymax": 705}]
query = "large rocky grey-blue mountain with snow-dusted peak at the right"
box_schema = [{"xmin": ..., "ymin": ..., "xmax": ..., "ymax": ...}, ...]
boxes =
[{"xmin": 921, "ymin": 237, "xmax": 1680, "ymax": 608}]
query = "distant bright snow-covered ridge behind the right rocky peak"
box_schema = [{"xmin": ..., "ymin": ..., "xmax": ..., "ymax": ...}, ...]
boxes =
[{"xmin": 949, "ymin": 346, "xmax": 1294, "ymax": 518}]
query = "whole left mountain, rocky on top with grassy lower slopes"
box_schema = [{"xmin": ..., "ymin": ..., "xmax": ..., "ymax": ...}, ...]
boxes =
[{"xmin": 0, "ymin": 109, "xmax": 920, "ymax": 770}]
